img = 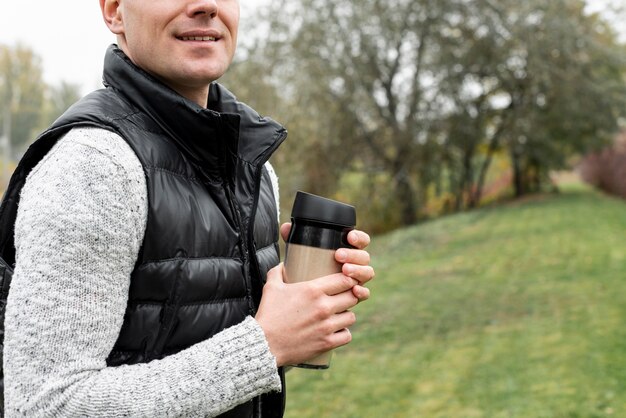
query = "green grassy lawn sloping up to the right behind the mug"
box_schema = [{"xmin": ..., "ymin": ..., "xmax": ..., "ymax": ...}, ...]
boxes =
[{"xmin": 286, "ymin": 185, "xmax": 626, "ymax": 418}]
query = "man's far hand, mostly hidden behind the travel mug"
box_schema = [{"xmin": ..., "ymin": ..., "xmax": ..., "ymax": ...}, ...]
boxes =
[{"xmin": 280, "ymin": 223, "xmax": 376, "ymax": 301}]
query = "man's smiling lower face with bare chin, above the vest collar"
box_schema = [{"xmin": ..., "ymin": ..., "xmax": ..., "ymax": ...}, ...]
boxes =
[{"xmin": 100, "ymin": 0, "xmax": 239, "ymax": 103}]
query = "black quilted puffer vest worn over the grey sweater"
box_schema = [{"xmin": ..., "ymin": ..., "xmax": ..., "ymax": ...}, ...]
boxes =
[{"xmin": 0, "ymin": 46, "xmax": 286, "ymax": 418}]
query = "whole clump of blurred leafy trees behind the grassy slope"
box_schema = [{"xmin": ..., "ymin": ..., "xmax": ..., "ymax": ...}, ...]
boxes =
[{"xmin": 222, "ymin": 0, "xmax": 626, "ymax": 232}]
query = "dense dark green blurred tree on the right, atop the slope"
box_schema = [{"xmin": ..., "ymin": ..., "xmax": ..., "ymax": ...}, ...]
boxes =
[{"xmin": 440, "ymin": 0, "xmax": 625, "ymax": 201}]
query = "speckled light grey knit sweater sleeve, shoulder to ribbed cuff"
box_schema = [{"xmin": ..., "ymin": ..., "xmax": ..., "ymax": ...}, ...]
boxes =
[{"xmin": 4, "ymin": 128, "xmax": 280, "ymax": 417}]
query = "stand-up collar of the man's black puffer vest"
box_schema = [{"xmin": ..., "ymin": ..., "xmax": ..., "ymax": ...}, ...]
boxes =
[{"xmin": 103, "ymin": 45, "xmax": 287, "ymax": 171}]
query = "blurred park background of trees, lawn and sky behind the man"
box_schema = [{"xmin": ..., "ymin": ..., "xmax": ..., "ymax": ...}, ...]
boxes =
[{"xmin": 0, "ymin": 0, "xmax": 626, "ymax": 418}]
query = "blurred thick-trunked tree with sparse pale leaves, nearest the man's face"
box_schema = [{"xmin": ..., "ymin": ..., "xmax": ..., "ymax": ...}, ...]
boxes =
[{"xmin": 258, "ymin": 0, "xmax": 464, "ymax": 224}]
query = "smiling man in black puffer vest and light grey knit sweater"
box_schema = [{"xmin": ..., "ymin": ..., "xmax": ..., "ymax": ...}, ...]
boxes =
[{"xmin": 0, "ymin": 0, "xmax": 374, "ymax": 417}]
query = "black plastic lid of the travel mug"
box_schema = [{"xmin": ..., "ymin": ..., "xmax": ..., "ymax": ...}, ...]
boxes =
[{"xmin": 291, "ymin": 191, "xmax": 356, "ymax": 228}]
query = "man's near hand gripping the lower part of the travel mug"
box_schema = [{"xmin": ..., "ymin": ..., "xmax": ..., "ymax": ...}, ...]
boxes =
[{"xmin": 256, "ymin": 264, "xmax": 359, "ymax": 366}]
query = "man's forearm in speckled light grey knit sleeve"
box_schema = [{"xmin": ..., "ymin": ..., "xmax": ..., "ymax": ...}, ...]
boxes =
[{"xmin": 33, "ymin": 318, "xmax": 280, "ymax": 417}]
